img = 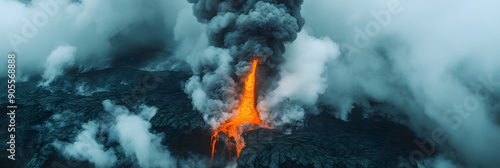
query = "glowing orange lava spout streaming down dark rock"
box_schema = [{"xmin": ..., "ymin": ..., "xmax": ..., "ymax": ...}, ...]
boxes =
[{"xmin": 212, "ymin": 60, "xmax": 262, "ymax": 158}]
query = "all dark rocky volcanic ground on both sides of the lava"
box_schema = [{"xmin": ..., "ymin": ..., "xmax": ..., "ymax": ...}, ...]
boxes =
[{"xmin": 0, "ymin": 68, "xmax": 422, "ymax": 167}]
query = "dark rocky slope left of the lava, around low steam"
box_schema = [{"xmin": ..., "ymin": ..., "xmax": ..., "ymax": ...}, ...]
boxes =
[{"xmin": 0, "ymin": 68, "xmax": 210, "ymax": 167}]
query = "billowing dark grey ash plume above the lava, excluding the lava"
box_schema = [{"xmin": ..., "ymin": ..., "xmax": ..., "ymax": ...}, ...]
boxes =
[{"xmin": 186, "ymin": 0, "xmax": 304, "ymax": 126}]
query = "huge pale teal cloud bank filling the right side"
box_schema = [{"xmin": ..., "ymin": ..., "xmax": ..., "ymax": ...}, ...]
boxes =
[{"xmin": 303, "ymin": 0, "xmax": 500, "ymax": 167}]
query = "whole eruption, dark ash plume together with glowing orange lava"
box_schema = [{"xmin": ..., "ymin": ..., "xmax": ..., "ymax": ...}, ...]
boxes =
[{"xmin": 185, "ymin": 0, "xmax": 304, "ymax": 163}]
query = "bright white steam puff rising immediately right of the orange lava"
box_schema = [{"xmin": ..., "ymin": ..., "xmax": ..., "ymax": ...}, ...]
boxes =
[{"xmin": 257, "ymin": 31, "xmax": 340, "ymax": 125}]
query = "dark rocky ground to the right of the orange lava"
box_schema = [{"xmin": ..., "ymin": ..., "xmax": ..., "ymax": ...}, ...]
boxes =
[{"xmin": 238, "ymin": 113, "xmax": 416, "ymax": 168}]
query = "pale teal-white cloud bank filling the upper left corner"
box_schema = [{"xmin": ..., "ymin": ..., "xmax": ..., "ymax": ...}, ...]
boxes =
[{"xmin": 0, "ymin": 0, "xmax": 188, "ymax": 79}]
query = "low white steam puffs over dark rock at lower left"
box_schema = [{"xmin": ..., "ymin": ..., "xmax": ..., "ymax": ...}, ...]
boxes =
[{"xmin": 53, "ymin": 100, "xmax": 177, "ymax": 168}]
